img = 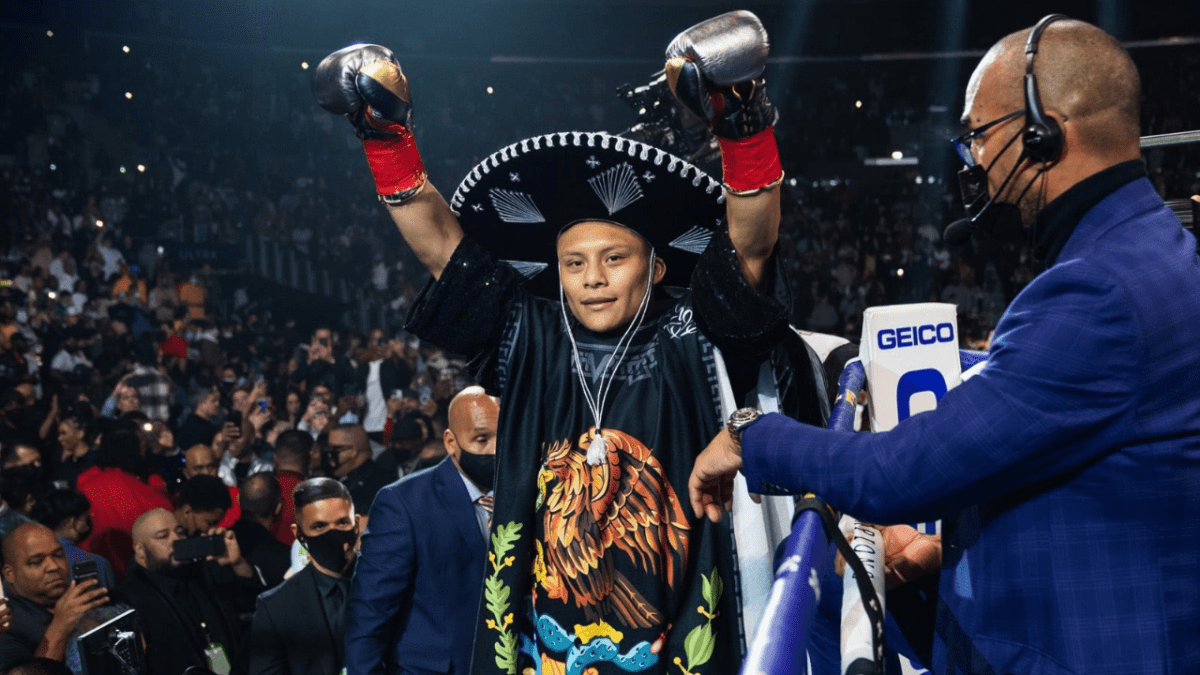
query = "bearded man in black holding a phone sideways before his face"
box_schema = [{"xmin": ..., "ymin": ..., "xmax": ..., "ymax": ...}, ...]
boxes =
[{"xmin": 116, "ymin": 509, "xmax": 263, "ymax": 674}]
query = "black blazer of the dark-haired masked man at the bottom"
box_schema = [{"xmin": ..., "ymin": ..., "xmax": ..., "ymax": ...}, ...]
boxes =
[{"xmin": 250, "ymin": 565, "xmax": 346, "ymax": 675}]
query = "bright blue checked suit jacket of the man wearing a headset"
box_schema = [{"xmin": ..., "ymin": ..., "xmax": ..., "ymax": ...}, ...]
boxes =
[{"xmin": 744, "ymin": 174, "xmax": 1200, "ymax": 675}]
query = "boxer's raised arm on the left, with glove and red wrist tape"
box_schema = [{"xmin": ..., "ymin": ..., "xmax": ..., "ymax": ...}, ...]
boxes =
[{"xmin": 312, "ymin": 44, "xmax": 462, "ymax": 279}]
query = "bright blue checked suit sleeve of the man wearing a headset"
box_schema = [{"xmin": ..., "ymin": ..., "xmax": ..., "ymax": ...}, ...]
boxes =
[{"xmin": 743, "ymin": 262, "xmax": 1145, "ymax": 524}]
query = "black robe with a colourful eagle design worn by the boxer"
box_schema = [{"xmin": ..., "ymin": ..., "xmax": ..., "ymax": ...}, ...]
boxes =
[{"xmin": 407, "ymin": 232, "xmax": 808, "ymax": 675}]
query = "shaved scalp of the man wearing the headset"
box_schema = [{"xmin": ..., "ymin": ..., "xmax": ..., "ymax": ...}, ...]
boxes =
[{"xmin": 964, "ymin": 19, "xmax": 1141, "ymax": 161}]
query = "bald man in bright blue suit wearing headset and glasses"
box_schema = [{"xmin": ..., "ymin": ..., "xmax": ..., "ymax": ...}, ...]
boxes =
[{"xmin": 689, "ymin": 17, "xmax": 1200, "ymax": 675}]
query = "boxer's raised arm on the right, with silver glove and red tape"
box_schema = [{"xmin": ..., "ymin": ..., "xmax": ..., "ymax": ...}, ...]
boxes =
[{"xmin": 665, "ymin": 11, "xmax": 784, "ymax": 289}]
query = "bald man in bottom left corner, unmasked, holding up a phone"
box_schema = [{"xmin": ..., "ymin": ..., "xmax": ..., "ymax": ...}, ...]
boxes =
[{"xmin": 0, "ymin": 522, "xmax": 108, "ymax": 673}]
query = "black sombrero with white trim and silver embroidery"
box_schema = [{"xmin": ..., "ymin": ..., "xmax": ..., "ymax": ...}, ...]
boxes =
[{"xmin": 450, "ymin": 131, "xmax": 725, "ymax": 298}]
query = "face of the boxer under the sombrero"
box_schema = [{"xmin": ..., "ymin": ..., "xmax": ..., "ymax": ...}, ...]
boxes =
[{"xmin": 558, "ymin": 221, "xmax": 666, "ymax": 333}]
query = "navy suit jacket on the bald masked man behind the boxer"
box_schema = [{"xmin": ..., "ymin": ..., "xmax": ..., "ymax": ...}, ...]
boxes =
[{"xmin": 346, "ymin": 459, "xmax": 486, "ymax": 675}]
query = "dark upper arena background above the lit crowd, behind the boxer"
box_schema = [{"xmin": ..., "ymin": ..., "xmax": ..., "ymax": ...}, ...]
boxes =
[{"xmin": 0, "ymin": 0, "xmax": 1200, "ymax": 340}]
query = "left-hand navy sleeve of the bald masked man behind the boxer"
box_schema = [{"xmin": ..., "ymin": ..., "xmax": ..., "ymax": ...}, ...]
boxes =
[{"xmin": 346, "ymin": 488, "xmax": 416, "ymax": 675}]
